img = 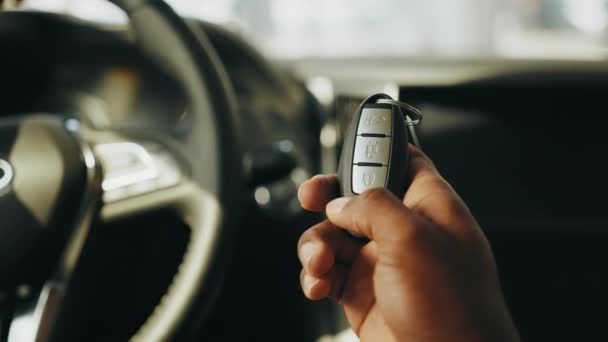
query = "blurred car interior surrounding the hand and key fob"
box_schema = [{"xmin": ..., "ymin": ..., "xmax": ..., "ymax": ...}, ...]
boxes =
[{"xmin": 0, "ymin": 0, "xmax": 608, "ymax": 342}]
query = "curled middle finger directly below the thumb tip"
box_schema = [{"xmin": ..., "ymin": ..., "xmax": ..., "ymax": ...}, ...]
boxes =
[{"xmin": 298, "ymin": 220, "xmax": 362, "ymax": 277}]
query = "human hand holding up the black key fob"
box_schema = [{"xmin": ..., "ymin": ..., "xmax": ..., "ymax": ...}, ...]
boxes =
[{"xmin": 298, "ymin": 146, "xmax": 519, "ymax": 342}]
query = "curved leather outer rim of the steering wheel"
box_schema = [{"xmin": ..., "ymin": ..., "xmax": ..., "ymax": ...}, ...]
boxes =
[{"xmin": 105, "ymin": 0, "xmax": 243, "ymax": 341}]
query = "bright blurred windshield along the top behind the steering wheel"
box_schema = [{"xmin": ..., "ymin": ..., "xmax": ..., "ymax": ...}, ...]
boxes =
[{"xmin": 17, "ymin": 0, "xmax": 608, "ymax": 59}]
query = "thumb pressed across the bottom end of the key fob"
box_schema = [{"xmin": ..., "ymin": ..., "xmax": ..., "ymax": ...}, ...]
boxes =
[{"xmin": 325, "ymin": 188, "xmax": 417, "ymax": 247}]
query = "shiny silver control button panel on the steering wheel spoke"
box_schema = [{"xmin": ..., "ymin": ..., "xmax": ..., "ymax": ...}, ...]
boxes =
[{"xmin": 95, "ymin": 142, "xmax": 181, "ymax": 203}]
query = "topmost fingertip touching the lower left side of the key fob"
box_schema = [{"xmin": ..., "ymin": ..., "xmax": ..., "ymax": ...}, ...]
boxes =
[{"xmin": 298, "ymin": 175, "xmax": 338, "ymax": 211}]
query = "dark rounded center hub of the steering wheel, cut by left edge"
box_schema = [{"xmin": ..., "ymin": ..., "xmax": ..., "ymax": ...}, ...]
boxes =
[{"xmin": 0, "ymin": 116, "xmax": 86, "ymax": 290}]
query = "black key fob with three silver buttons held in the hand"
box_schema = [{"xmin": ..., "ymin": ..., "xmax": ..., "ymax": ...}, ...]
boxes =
[{"xmin": 338, "ymin": 94, "xmax": 421, "ymax": 198}]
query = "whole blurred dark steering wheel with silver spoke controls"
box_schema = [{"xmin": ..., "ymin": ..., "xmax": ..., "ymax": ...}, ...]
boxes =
[{"xmin": 0, "ymin": 0, "xmax": 244, "ymax": 342}]
